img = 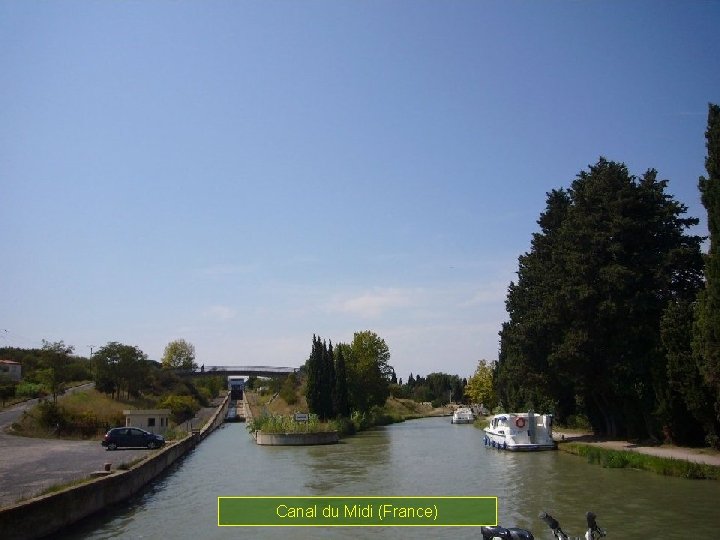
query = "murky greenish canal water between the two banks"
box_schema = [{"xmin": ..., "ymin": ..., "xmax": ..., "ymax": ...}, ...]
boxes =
[{"xmin": 60, "ymin": 418, "xmax": 720, "ymax": 540}]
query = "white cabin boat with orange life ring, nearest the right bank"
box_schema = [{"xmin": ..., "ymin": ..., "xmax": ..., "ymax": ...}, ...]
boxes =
[{"xmin": 484, "ymin": 411, "xmax": 557, "ymax": 450}]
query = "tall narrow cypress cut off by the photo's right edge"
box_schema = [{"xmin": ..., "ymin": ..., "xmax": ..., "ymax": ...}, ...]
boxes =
[{"xmin": 693, "ymin": 104, "xmax": 720, "ymax": 445}]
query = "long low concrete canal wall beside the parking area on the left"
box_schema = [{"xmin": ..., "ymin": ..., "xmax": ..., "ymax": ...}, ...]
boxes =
[{"xmin": 0, "ymin": 392, "xmax": 228, "ymax": 540}]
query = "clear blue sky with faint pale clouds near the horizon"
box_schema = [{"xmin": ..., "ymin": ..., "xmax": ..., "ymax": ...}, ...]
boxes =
[{"xmin": 0, "ymin": 0, "xmax": 720, "ymax": 378}]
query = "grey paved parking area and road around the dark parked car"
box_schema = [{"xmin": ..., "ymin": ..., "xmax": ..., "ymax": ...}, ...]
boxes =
[{"xmin": 0, "ymin": 387, "xmax": 151, "ymax": 507}]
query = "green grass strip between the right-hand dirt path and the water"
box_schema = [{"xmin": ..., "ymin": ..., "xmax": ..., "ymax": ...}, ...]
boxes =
[{"xmin": 558, "ymin": 443, "xmax": 720, "ymax": 480}]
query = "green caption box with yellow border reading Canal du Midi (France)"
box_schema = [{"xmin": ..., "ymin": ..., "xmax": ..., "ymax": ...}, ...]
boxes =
[{"xmin": 218, "ymin": 496, "xmax": 497, "ymax": 527}]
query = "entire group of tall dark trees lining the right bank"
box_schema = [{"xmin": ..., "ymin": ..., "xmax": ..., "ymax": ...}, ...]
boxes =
[{"xmin": 493, "ymin": 104, "xmax": 720, "ymax": 446}]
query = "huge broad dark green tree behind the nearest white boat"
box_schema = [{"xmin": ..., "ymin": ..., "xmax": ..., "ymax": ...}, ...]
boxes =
[{"xmin": 495, "ymin": 158, "xmax": 702, "ymax": 437}]
